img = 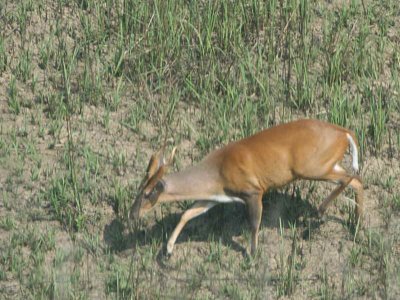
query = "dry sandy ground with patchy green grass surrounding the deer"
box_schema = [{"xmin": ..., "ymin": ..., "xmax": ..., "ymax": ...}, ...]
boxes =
[{"xmin": 0, "ymin": 0, "xmax": 400, "ymax": 299}]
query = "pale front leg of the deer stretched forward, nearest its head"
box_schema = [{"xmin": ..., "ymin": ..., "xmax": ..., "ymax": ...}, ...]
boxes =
[{"xmin": 167, "ymin": 201, "xmax": 218, "ymax": 254}]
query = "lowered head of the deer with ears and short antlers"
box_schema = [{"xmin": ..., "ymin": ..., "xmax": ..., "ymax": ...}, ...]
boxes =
[{"xmin": 130, "ymin": 147, "xmax": 176, "ymax": 220}]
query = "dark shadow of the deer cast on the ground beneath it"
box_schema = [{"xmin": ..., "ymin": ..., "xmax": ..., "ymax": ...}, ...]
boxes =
[{"xmin": 103, "ymin": 191, "xmax": 334, "ymax": 255}]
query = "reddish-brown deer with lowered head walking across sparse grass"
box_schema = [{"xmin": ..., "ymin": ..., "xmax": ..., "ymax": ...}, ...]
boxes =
[{"xmin": 130, "ymin": 119, "xmax": 363, "ymax": 256}]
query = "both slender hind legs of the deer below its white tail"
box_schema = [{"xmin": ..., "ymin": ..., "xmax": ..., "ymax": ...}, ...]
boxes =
[{"xmin": 318, "ymin": 164, "xmax": 364, "ymax": 220}]
